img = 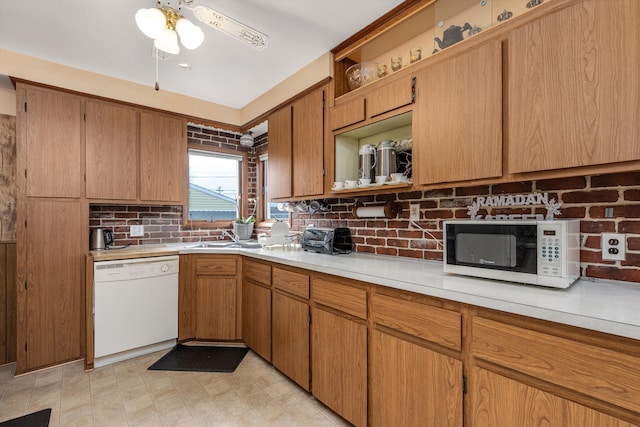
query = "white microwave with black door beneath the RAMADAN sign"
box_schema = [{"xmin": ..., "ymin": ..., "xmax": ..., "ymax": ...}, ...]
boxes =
[{"xmin": 443, "ymin": 219, "xmax": 580, "ymax": 288}]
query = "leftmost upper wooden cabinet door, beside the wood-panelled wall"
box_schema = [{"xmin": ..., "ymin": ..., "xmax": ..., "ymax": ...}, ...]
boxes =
[{"xmin": 24, "ymin": 87, "xmax": 84, "ymax": 197}]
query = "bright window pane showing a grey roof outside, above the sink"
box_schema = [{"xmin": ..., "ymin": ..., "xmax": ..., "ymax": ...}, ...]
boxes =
[{"xmin": 187, "ymin": 148, "xmax": 247, "ymax": 226}]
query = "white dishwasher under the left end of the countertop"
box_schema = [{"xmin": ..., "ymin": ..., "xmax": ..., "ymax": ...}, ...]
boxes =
[{"xmin": 93, "ymin": 256, "xmax": 179, "ymax": 367}]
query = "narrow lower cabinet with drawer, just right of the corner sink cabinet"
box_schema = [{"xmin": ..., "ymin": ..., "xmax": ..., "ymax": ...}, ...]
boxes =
[{"xmin": 242, "ymin": 260, "xmax": 271, "ymax": 362}]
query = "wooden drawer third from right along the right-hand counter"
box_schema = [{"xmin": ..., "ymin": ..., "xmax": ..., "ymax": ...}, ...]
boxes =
[{"xmin": 311, "ymin": 279, "xmax": 367, "ymax": 319}]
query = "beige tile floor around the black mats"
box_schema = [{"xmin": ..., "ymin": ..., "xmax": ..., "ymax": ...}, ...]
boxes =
[{"xmin": 0, "ymin": 351, "xmax": 349, "ymax": 427}]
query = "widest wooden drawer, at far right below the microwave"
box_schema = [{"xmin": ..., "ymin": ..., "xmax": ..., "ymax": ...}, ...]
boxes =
[{"xmin": 472, "ymin": 317, "xmax": 640, "ymax": 412}]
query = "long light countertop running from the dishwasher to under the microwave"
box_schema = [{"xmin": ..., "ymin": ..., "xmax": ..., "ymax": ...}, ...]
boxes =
[{"xmin": 91, "ymin": 244, "xmax": 640, "ymax": 340}]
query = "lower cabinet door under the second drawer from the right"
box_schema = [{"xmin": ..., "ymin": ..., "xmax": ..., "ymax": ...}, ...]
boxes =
[{"xmin": 369, "ymin": 330, "xmax": 462, "ymax": 427}]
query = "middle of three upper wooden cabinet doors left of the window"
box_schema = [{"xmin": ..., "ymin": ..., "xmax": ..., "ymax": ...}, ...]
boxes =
[{"xmin": 86, "ymin": 100, "xmax": 138, "ymax": 200}]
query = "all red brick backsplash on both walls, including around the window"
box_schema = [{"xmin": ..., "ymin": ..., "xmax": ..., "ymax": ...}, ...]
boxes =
[{"xmin": 90, "ymin": 126, "xmax": 640, "ymax": 283}]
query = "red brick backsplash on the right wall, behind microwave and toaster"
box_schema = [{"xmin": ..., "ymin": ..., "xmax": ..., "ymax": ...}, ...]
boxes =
[{"xmin": 292, "ymin": 172, "xmax": 640, "ymax": 282}]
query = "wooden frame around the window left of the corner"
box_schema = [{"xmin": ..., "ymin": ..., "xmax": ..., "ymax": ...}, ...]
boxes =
[{"xmin": 182, "ymin": 144, "xmax": 249, "ymax": 228}]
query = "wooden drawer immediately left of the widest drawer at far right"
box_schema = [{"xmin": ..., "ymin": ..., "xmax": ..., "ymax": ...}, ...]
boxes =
[{"xmin": 371, "ymin": 294, "xmax": 462, "ymax": 351}]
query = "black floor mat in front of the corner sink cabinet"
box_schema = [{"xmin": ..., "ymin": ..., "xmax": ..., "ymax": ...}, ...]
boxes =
[{"xmin": 149, "ymin": 344, "xmax": 249, "ymax": 372}]
